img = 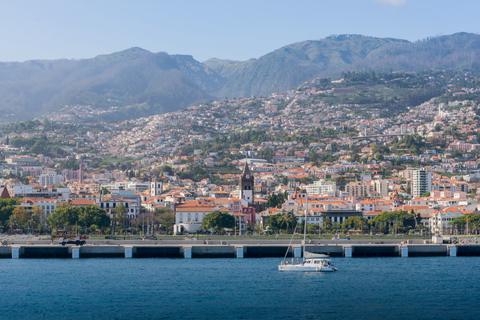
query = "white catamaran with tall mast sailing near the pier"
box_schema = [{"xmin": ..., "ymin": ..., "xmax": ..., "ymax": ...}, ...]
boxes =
[{"xmin": 278, "ymin": 195, "xmax": 337, "ymax": 272}]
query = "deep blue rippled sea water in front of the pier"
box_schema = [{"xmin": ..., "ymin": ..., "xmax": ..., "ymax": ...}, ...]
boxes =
[{"xmin": 0, "ymin": 257, "xmax": 480, "ymax": 319}]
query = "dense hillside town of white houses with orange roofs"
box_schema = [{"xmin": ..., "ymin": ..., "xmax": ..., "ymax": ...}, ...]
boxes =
[{"xmin": 0, "ymin": 73, "xmax": 480, "ymax": 238}]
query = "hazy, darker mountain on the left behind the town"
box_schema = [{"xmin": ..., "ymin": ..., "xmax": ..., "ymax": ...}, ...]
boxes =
[{"xmin": 0, "ymin": 48, "xmax": 218, "ymax": 120}]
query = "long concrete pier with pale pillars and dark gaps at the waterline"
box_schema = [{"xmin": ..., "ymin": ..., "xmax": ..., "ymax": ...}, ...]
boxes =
[{"xmin": 4, "ymin": 242, "xmax": 480, "ymax": 259}]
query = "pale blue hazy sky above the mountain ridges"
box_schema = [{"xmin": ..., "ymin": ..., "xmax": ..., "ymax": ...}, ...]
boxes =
[{"xmin": 0, "ymin": 0, "xmax": 480, "ymax": 61}]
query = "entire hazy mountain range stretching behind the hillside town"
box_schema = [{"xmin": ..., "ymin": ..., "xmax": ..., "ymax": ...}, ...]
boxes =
[{"xmin": 0, "ymin": 33, "xmax": 480, "ymax": 122}]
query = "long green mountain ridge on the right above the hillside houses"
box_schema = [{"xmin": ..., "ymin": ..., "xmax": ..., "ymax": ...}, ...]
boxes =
[{"xmin": 204, "ymin": 33, "xmax": 480, "ymax": 97}]
